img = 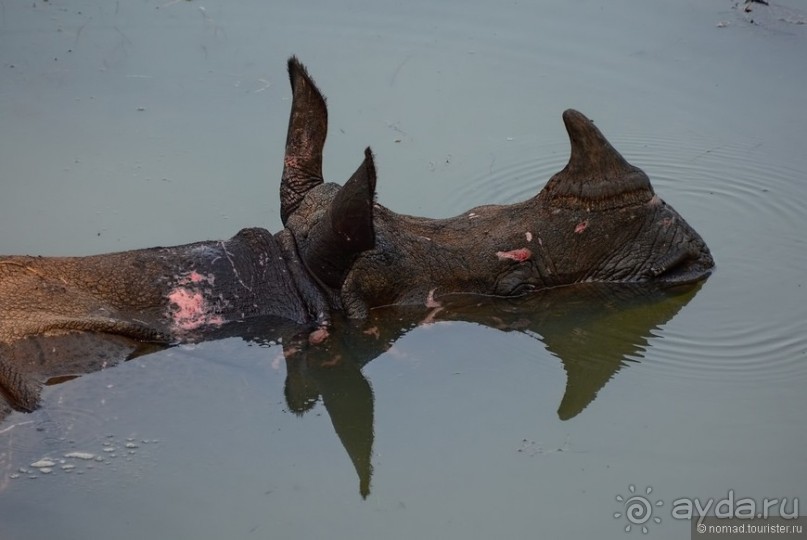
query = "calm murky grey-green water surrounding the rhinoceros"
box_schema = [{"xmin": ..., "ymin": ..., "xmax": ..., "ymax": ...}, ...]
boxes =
[{"xmin": 0, "ymin": 0, "xmax": 807, "ymax": 540}]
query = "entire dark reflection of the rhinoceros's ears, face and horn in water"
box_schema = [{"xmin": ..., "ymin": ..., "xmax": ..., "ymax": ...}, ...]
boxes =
[{"xmin": 276, "ymin": 283, "xmax": 699, "ymax": 497}]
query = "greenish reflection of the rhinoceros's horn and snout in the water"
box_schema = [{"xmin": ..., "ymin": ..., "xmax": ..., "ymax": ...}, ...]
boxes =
[{"xmin": 422, "ymin": 283, "xmax": 700, "ymax": 420}]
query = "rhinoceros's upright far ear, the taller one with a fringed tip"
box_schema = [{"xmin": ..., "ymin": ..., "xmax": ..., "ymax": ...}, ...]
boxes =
[{"xmin": 280, "ymin": 56, "xmax": 328, "ymax": 225}]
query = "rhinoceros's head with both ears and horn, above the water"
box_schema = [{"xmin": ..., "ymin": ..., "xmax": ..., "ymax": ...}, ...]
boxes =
[{"xmin": 281, "ymin": 58, "xmax": 714, "ymax": 317}]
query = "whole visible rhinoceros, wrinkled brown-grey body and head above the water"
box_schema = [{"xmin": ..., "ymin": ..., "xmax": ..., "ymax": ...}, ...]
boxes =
[{"xmin": 0, "ymin": 58, "xmax": 714, "ymax": 418}]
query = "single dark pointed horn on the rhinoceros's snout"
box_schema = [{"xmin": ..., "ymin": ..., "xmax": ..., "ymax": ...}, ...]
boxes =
[{"xmin": 538, "ymin": 109, "xmax": 653, "ymax": 210}]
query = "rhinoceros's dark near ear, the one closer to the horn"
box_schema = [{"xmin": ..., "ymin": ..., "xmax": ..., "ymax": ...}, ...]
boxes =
[{"xmin": 303, "ymin": 148, "xmax": 376, "ymax": 289}]
